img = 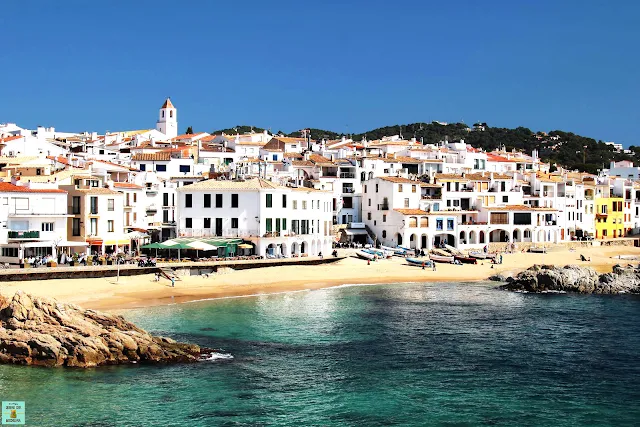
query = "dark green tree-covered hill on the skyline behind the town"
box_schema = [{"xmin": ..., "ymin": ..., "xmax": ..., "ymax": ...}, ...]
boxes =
[{"xmin": 214, "ymin": 122, "xmax": 640, "ymax": 174}]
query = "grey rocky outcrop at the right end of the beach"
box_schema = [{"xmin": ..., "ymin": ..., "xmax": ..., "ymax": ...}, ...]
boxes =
[{"xmin": 501, "ymin": 265, "xmax": 640, "ymax": 294}]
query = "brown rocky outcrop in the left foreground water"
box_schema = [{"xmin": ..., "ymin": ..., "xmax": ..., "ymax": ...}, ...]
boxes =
[{"xmin": 0, "ymin": 291, "xmax": 204, "ymax": 368}]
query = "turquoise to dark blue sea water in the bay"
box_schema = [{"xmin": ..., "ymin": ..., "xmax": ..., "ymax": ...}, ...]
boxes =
[{"xmin": 0, "ymin": 284, "xmax": 640, "ymax": 426}]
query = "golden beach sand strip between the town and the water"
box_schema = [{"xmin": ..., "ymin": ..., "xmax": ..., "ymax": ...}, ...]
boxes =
[{"xmin": 0, "ymin": 246, "xmax": 640, "ymax": 310}]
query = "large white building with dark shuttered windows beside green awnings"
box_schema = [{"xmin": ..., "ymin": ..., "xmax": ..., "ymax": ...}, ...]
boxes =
[{"xmin": 177, "ymin": 178, "xmax": 332, "ymax": 257}]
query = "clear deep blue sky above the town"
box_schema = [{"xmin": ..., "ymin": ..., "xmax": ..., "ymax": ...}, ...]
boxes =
[{"xmin": 0, "ymin": 0, "xmax": 640, "ymax": 145}]
